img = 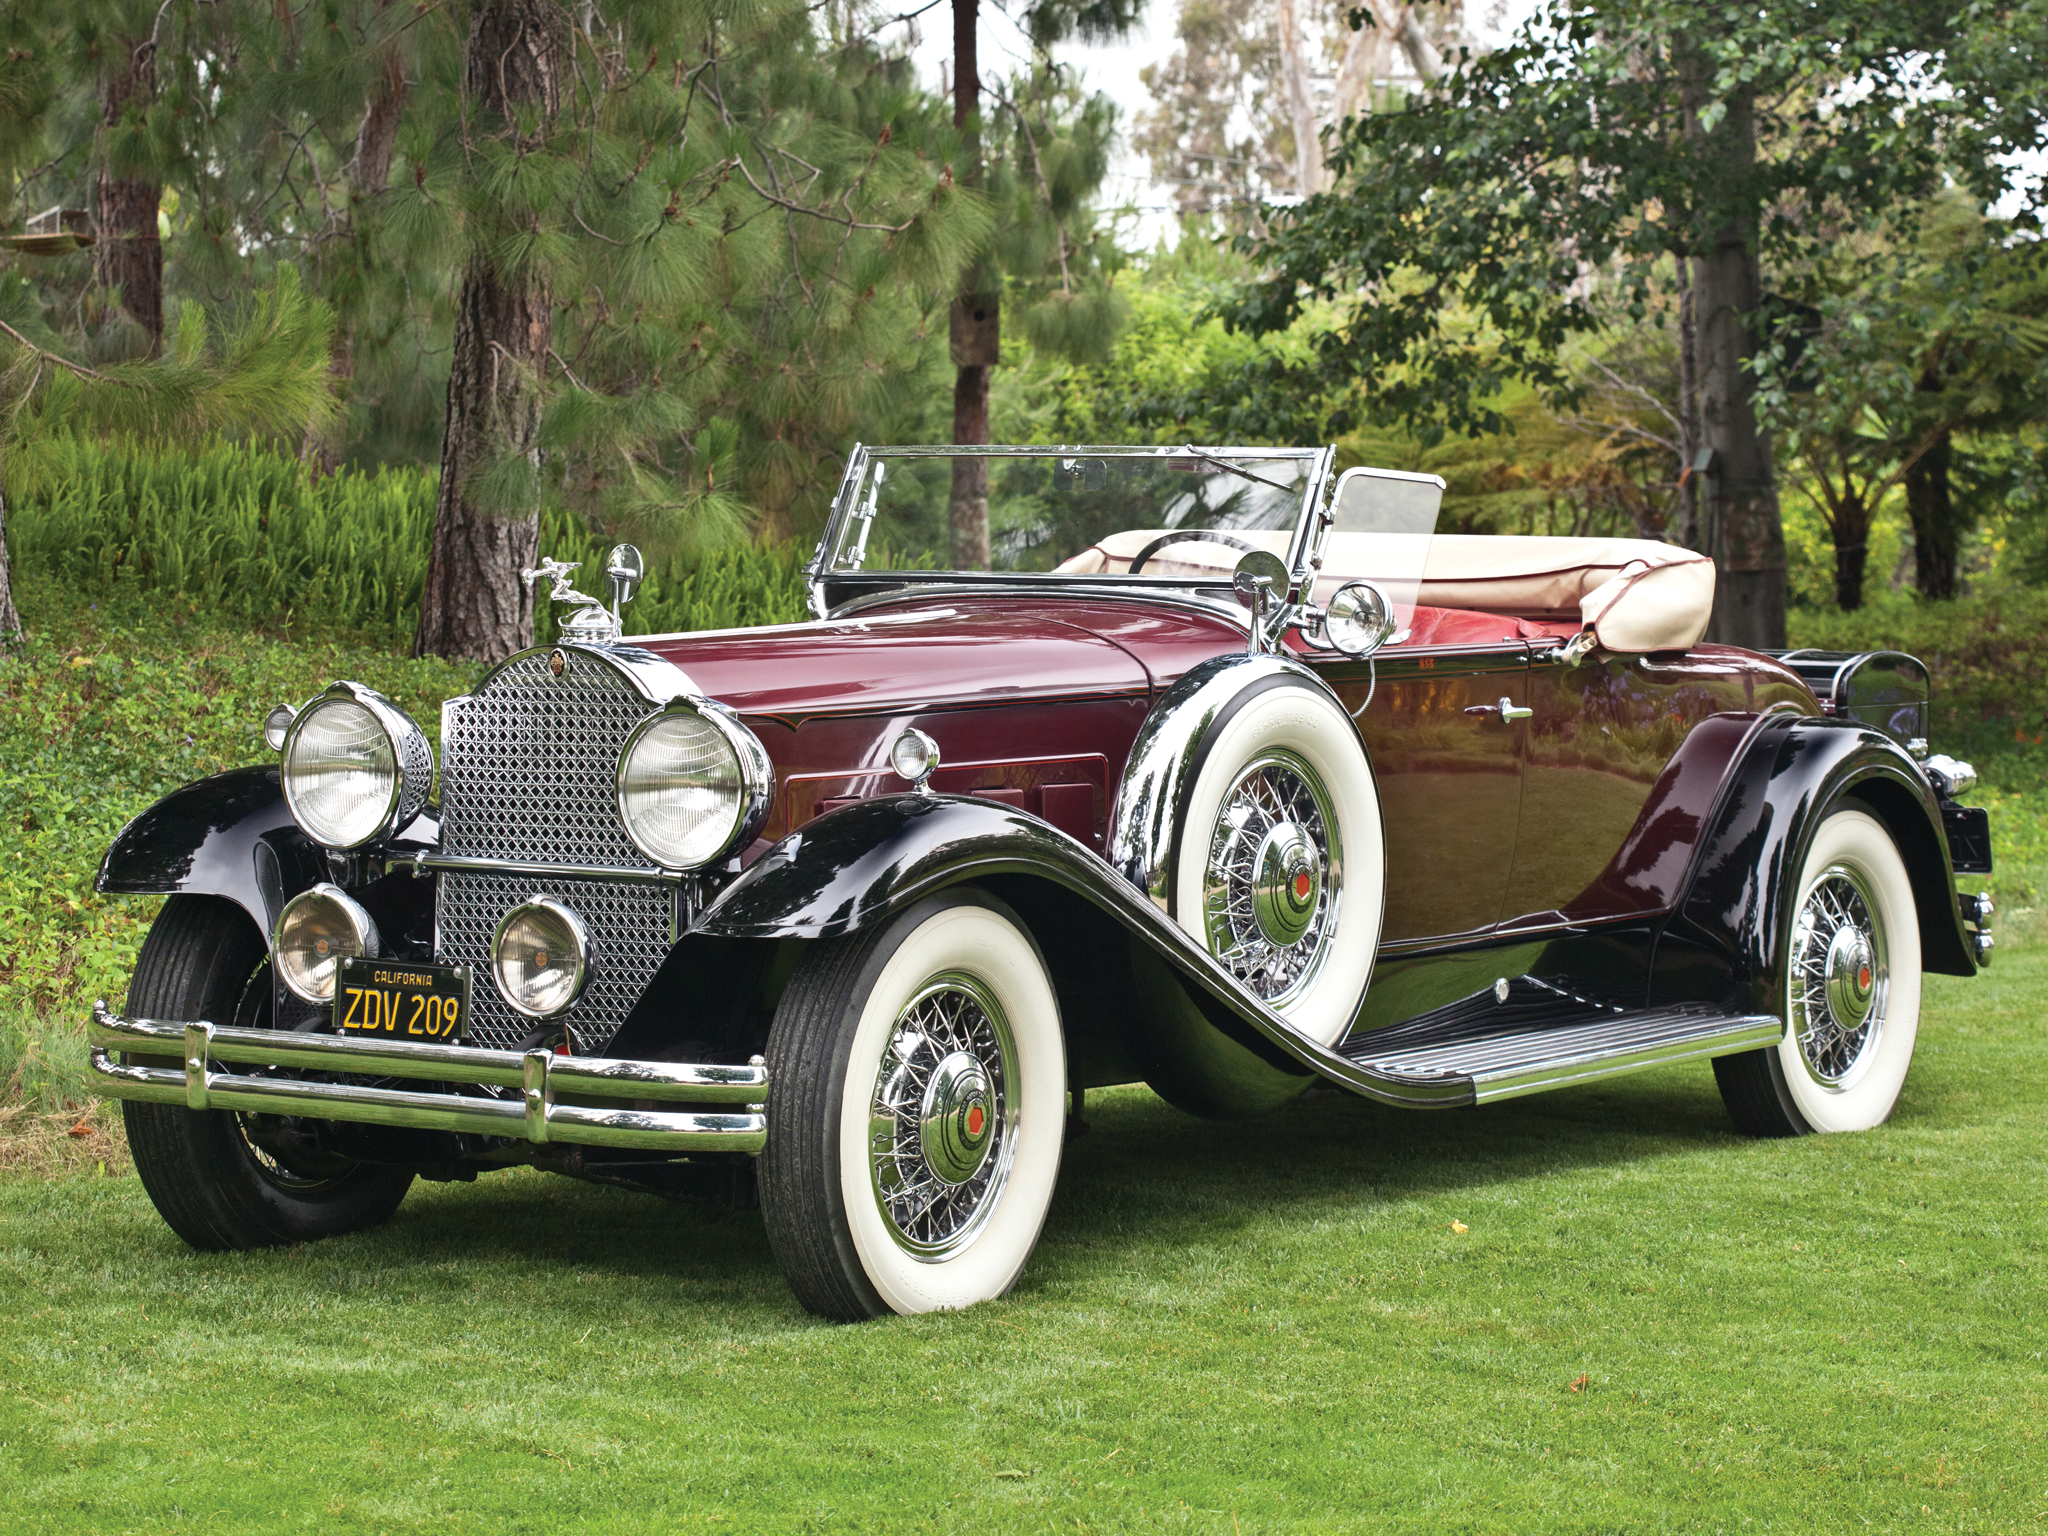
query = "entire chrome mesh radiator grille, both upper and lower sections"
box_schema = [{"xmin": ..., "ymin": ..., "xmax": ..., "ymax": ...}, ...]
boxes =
[{"xmin": 434, "ymin": 649, "xmax": 676, "ymax": 1055}]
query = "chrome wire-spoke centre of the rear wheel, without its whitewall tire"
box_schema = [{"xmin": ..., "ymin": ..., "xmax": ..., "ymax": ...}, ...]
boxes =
[{"xmin": 1790, "ymin": 864, "xmax": 1888, "ymax": 1087}]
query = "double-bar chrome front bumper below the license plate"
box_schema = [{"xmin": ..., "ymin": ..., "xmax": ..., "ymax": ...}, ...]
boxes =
[{"xmin": 86, "ymin": 1001, "xmax": 768, "ymax": 1155}]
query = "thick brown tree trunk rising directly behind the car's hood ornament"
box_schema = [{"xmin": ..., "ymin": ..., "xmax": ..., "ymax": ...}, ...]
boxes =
[{"xmin": 412, "ymin": 0, "xmax": 569, "ymax": 662}]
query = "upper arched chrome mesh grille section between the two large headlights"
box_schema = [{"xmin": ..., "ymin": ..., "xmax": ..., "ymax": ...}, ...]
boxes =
[{"xmin": 440, "ymin": 651, "xmax": 653, "ymax": 868}]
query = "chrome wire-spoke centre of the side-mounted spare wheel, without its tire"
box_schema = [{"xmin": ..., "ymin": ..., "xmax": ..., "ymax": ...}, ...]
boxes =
[{"xmin": 1202, "ymin": 752, "xmax": 1343, "ymax": 1006}]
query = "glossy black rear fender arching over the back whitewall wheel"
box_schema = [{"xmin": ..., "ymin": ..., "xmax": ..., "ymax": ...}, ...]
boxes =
[{"xmin": 1653, "ymin": 715, "xmax": 1976, "ymax": 1014}]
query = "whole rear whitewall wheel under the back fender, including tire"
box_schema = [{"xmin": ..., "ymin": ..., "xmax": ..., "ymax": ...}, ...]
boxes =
[{"xmin": 1714, "ymin": 801, "xmax": 1921, "ymax": 1137}]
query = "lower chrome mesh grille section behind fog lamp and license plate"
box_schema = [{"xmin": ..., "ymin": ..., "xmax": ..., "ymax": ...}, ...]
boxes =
[{"xmin": 434, "ymin": 870, "xmax": 676, "ymax": 1055}]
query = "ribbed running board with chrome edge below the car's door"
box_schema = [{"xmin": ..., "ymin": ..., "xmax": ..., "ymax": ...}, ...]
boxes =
[{"xmin": 1339, "ymin": 1004, "xmax": 1786, "ymax": 1104}]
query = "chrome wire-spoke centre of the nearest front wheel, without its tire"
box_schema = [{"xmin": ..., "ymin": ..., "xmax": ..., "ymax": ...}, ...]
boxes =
[{"xmin": 868, "ymin": 973, "xmax": 1016, "ymax": 1262}]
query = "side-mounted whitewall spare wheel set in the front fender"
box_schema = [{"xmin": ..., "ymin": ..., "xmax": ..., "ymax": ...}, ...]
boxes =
[{"xmin": 1171, "ymin": 682, "xmax": 1386, "ymax": 1044}]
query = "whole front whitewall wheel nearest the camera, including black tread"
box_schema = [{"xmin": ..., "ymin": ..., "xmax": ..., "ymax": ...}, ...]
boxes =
[{"xmin": 760, "ymin": 891, "xmax": 1067, "ymax": 1321}]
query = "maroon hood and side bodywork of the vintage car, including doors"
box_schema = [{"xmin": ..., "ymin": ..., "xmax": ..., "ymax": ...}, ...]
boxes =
[{"xmin": 641, "ymin": 594, "xmax": 1819, "ymax": 952}]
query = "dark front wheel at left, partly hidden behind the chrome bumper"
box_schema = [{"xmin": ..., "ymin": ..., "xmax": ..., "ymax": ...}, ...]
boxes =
[{"xmin": 121, "ymin": 895, "xmax": 412, "ymax": 1249}]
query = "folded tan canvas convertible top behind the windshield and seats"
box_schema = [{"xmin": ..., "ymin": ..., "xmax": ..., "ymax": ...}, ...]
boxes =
[{"xmin": 1059, "ymin": 528, "xmax": 1714, "ymax": 651}]
